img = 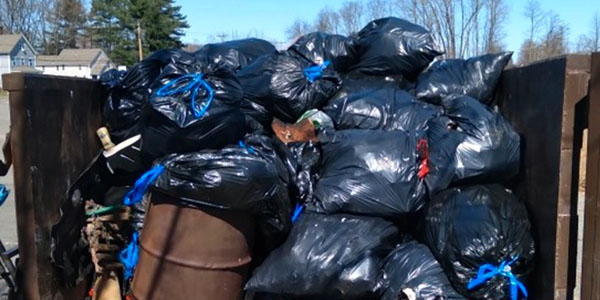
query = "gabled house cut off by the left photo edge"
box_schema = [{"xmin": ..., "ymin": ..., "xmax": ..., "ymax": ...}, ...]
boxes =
[{"xmin": 0, "ymin": 34, "xmax": 39, "ymax": 88}]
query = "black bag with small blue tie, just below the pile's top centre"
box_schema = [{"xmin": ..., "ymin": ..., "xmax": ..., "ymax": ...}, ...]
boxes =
[{"xmin": 237, "ymin": 54, "xmax": 342, "ymax": 123}]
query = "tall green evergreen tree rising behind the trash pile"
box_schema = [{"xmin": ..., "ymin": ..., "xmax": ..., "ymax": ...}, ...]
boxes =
[{"xmin": 90, "ymin": 0, "xmax": 189, "ymax": 65}]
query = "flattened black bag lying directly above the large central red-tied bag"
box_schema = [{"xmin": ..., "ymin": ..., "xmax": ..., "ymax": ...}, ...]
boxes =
[{"xmin": 323, "ymin": 88, "xmax": 441, "ymax": 131}]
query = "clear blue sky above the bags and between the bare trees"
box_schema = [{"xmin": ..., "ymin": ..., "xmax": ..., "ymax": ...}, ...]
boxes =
[{"xmin": 176, "ymin": 0, "xmax": 600, "ymax": 51}]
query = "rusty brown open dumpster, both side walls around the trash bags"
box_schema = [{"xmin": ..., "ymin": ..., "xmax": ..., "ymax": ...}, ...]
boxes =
[{"xmin": 3, "ymin": 53, "xmax": 600, "ymax": 300}]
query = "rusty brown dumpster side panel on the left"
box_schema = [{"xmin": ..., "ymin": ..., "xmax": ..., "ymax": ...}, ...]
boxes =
[{"xmin": 4, "ymin": 74, "xmax": 104, "ymax": 299}]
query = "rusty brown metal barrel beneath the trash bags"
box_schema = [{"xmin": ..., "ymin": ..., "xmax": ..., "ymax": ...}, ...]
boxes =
[{"xmin": 131, "ymin": 191, "xmax": 255, "ymax": 300}]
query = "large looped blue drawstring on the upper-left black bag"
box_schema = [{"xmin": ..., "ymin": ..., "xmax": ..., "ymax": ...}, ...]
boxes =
[{"xmin": 156, "ymin": 73, "xmax": 215, "ymax": 118}]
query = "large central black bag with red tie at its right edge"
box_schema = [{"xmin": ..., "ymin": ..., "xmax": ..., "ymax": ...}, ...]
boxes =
[{"xmin": 307, "ymin": 129, "xmax": 426, "ymax": 217}]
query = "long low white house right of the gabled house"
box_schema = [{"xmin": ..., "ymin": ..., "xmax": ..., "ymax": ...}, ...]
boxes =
[{"xmin": 36, "ymin": 49, "xmax": 114, "ymax": 78}]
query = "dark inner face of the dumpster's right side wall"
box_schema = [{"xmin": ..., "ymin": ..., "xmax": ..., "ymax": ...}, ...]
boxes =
[{"xmin": 496, "ymin": 58, "xmax": 566, "ymax": 299}]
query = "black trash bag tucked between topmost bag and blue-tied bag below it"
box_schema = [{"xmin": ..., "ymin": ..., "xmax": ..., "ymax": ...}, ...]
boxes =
[{"xmin": 288, "ymin": 32, "xmax": 357, "ymax": 73}]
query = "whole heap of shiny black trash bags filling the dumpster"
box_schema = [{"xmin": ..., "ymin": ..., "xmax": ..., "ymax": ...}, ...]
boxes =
[{"xmin": 53, "ymin": 17, "xmax": 535, "ymax": 300}]
